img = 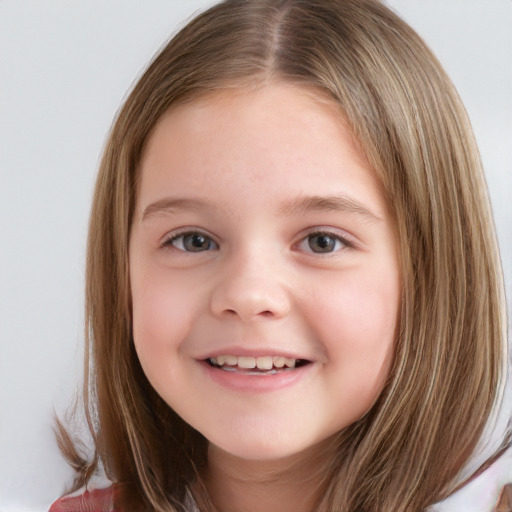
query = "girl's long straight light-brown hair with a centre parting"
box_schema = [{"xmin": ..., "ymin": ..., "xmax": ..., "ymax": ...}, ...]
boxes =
[{"xmin": 60, "ymin": 0, "xmax": 506, "ymax": 512}]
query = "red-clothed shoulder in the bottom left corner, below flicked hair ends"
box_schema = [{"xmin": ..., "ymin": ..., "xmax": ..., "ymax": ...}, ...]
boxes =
[{"xmin": 48, "ymin": 484, "xmax": 121, "ymax": 512}]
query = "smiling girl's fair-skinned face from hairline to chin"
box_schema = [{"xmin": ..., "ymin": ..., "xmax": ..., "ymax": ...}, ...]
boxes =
[{"xmin": 130, "ymin": 84, "xmax": 400, "ymax": 460}]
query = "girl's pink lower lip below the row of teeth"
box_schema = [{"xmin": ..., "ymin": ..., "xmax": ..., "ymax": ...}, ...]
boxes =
[{"xmin": 200, "ymin": 361, "xmax": 315, "ymax": 393}]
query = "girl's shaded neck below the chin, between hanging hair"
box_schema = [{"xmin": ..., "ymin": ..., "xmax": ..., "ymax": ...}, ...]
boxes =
[{"xmin": 205, "ymin": 445, "xmax": 329, "ymax": 512}]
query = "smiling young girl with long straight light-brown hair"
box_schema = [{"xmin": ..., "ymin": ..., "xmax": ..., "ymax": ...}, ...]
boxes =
[{"xmin": 51, "ymin": 0, "xmax": 509, "ymax": 512}]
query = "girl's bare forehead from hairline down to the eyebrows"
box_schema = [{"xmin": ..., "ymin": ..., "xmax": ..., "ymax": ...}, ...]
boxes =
[{"xmin": 134, "ymin": 83, "xmax": 382, "ymax": 219}]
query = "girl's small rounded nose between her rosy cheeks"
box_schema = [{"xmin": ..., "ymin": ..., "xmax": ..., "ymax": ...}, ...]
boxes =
[{"xmin": 211, "ymin": 247, "xmax": 290, "ymax": 322}]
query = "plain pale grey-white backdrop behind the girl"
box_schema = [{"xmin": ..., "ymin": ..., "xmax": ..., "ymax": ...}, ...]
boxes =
[{"xmin": 0, "ymin": 0, "xmax": 512, "ymax": 512}]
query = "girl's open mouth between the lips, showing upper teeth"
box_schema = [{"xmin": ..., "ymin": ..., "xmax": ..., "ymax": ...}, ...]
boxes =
[{"xmin": 205, "ymin": 354, "xmax": 311, "ymax": 375}]
